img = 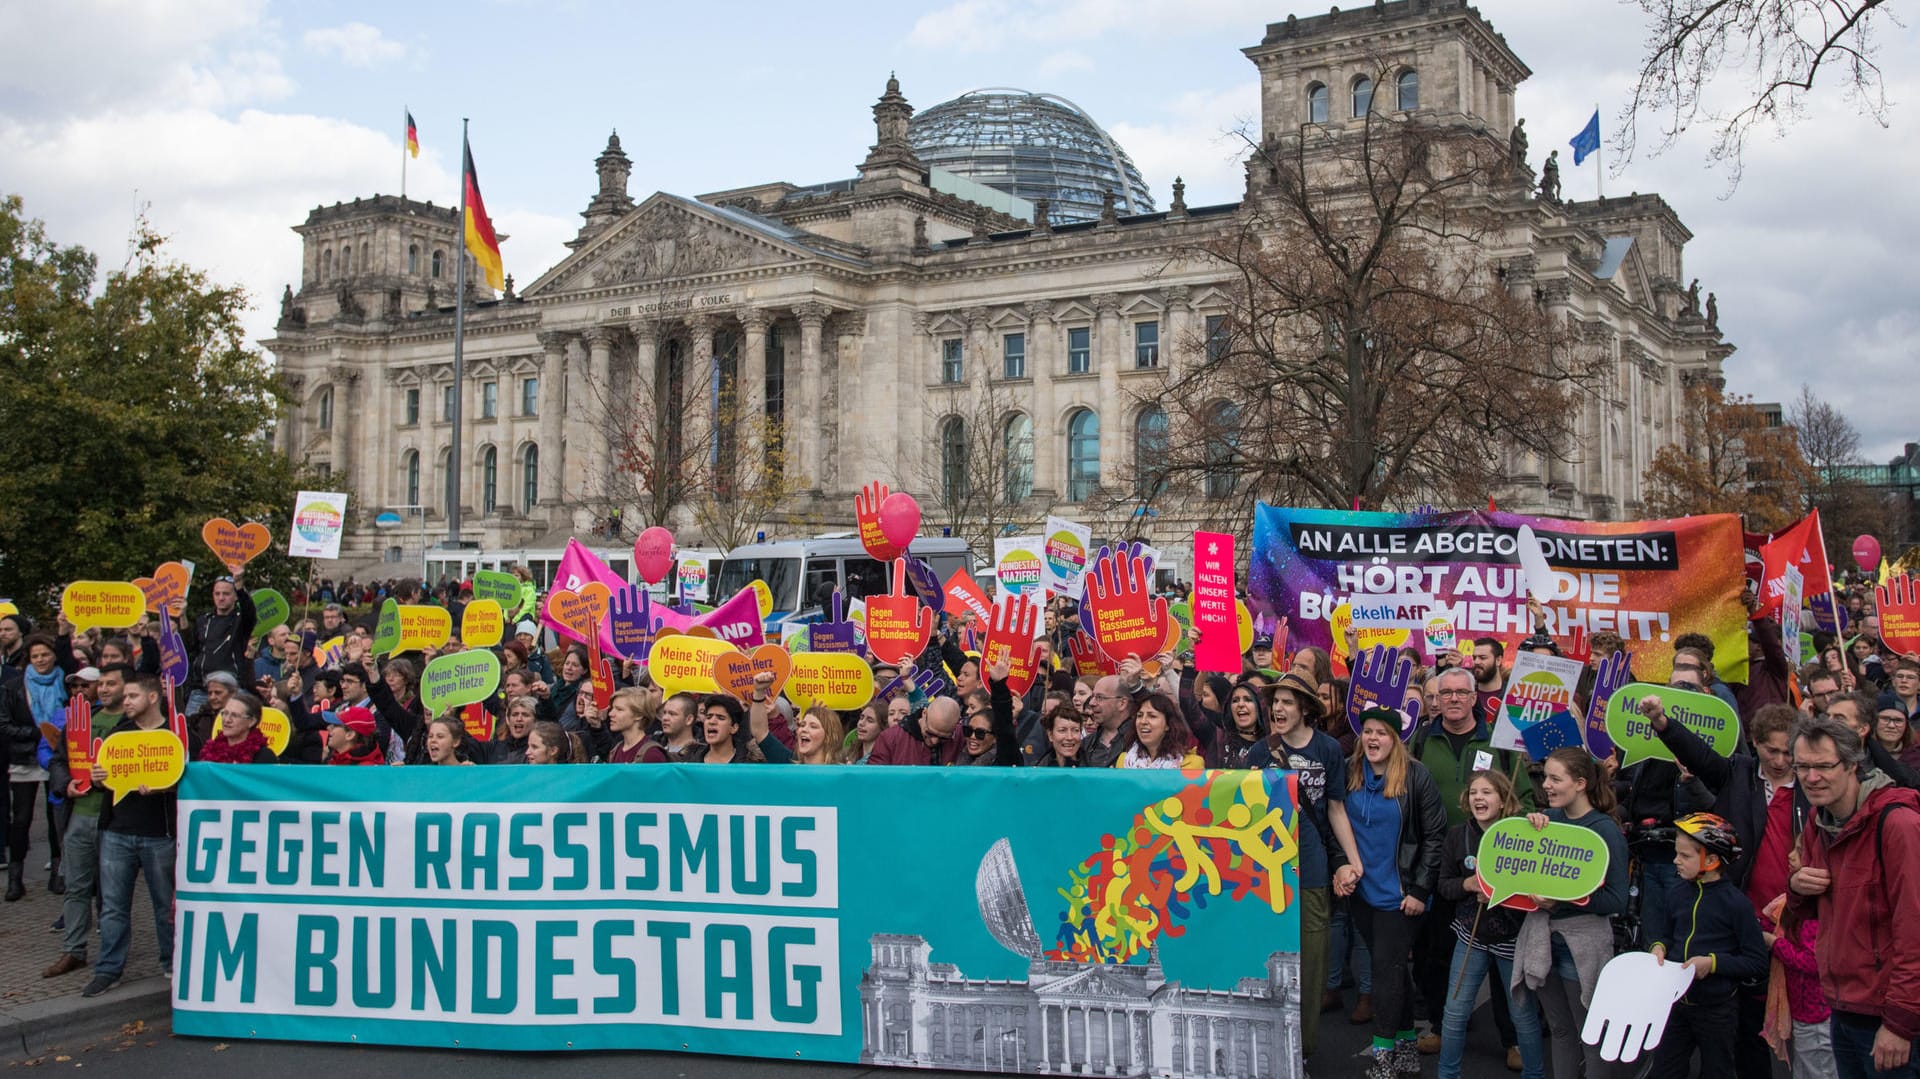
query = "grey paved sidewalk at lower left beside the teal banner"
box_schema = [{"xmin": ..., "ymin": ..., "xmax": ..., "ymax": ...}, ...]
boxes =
[{"xmin": 0, "ymin": 837, "xmax": 167, "ymax": 1048}]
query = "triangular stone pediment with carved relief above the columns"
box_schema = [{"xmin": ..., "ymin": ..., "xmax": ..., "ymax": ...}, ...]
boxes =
[{"xmin": 526, "ymin": 196, "xmax": 808, "ymax": 294}]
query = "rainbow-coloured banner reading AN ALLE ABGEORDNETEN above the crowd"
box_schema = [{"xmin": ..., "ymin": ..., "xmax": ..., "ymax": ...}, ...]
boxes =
[{"xmin": 1250, "ymin": 503, "xmax": 1747, "ymax": 682}]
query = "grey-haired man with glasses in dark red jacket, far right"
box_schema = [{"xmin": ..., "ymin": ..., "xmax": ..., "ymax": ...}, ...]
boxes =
[{"xmin": 1788, "ymin": 716, "xmax": 1920, "ymax": 1079}]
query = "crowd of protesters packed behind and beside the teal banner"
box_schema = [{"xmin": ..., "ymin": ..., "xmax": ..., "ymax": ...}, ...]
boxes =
[{"xmin": 0, "ymin": 503, "xmax": 1920, "ymax": 1079}]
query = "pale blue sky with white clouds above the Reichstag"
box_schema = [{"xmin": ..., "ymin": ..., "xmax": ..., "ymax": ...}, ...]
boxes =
[{"xmin": 0, "ymin": 0, "xmax": 1920, "ymax": 461}]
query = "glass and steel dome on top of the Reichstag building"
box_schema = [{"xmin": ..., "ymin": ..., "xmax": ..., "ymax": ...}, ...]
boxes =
[{"xmin": 908, "ymin": 86, "xmax": 1154, "ymax": 225}]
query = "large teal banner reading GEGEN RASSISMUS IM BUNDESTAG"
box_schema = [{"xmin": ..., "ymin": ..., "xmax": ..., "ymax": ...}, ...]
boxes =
[{"xmin": 173, "ymin": 764, "xmax": 1317, "ymax": 1077}]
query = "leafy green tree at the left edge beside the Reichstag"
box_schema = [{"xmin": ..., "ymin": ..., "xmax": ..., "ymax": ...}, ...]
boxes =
[{"xmin": 0, "ymin": 196, "xmax": 324, "ymax": 614}]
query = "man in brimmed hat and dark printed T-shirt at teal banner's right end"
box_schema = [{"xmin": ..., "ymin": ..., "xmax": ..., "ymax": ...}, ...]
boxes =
[{"xmin": 1246, "ymin": 668, "xmax": 1359, "ymax": 1054}]
